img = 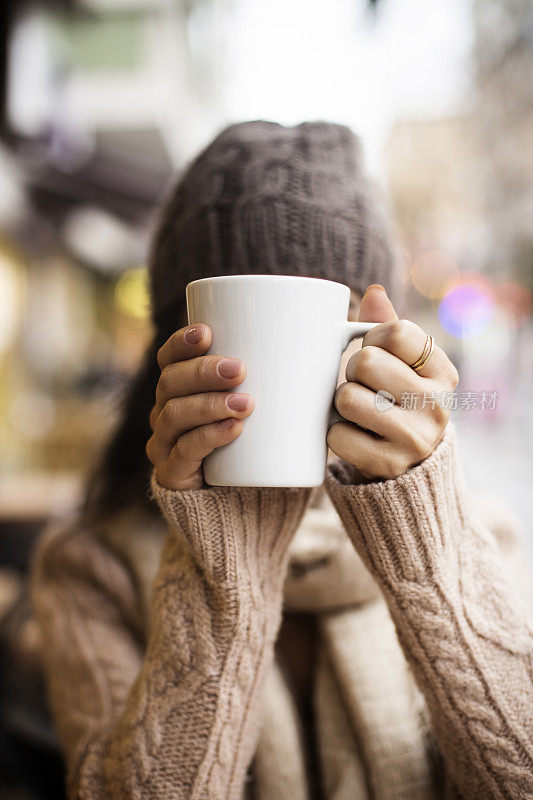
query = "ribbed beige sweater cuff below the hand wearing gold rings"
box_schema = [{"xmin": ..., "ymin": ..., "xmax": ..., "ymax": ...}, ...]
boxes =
[{"xmin": 326, "ymin": 426, "xmax": 468, "ymax": 585}]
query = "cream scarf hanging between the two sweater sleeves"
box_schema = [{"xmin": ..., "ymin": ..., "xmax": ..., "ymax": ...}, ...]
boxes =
[{"xmin": 254, "ymin": 504, "xmax": 434, "ymax": 800}]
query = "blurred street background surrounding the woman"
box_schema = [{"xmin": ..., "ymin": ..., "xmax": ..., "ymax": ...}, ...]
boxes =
[{"xmin": 0, "ymin": 0, "xmax": 533, "ymax": 797}]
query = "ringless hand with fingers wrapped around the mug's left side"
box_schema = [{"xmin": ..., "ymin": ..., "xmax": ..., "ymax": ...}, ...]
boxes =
[{"xmin": 146, "ymin": 323, "xmax": 254, "ymax": 489}]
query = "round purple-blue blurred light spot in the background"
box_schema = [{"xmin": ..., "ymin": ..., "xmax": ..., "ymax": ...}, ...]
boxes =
[{"xmin": 439, "ymin": 276, "xmax": 494, "ymax": 339}]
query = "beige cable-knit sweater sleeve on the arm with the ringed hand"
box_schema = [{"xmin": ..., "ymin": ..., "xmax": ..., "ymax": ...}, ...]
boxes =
[{"xmin": 326, "ymin": 429, "xmax": 533, "ymax": 800}]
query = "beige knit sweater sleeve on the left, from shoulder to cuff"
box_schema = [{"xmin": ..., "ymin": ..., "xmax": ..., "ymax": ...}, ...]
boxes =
[{"xmin": 32, "ymin": 478, "xmax": 310, "ymax": 800}]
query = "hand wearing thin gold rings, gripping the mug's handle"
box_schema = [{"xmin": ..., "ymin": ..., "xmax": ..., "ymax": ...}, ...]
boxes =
[{"xmin": 327, "ymin": 285, "xmax": 459, "ymax": 480}]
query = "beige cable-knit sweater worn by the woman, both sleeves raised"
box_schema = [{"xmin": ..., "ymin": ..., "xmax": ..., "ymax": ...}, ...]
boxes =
[{"xmin": 33, "ymin": 431, "xmax": 533, "ymax": 800}]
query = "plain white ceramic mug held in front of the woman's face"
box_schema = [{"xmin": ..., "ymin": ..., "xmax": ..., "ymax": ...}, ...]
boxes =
[{"xmin": 186, "ymin": 275, "xmax": 375, "ymax": 486}]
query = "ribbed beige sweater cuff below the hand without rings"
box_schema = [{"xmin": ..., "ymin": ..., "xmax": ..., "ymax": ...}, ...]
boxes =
[{"xmin": 150, "ymin": 470, "xmax": 312, "ymax": 584}]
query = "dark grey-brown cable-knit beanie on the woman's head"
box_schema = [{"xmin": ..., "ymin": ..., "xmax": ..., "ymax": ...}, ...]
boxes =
[{"xmin": 150, "ymin": 120, "xmax": 398, "ymax": 330}]
